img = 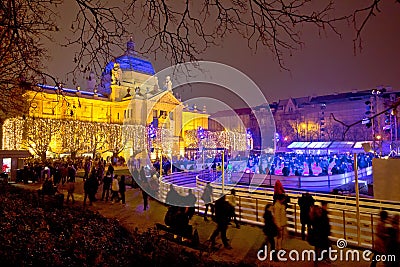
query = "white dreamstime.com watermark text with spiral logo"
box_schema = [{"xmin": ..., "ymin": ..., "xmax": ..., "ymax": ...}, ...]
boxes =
[{"xmin": 257, "ymin": 239, "xmax": 396, "ymax": 262}]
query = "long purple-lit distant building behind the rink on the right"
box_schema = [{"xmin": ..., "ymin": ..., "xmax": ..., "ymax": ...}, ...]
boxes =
[{"xmin": 209, "ymin": 88, "xmax": 400, "ymax": 152}]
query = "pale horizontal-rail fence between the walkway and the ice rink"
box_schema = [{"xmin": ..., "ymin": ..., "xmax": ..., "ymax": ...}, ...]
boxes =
[{"xmin": 159, "ymin": 173, "xmax": 400, "ymax": 251}]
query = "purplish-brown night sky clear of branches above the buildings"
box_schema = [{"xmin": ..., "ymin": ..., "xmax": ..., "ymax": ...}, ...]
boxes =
[{"xmin": 48, "ymin": 0, "xmax": 400, "ymax": 110}]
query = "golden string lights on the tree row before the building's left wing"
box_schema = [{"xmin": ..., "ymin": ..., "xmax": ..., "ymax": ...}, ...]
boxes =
[{"xmin": 3, "ymin": 117, "xmax": 135, "ymax": 157}]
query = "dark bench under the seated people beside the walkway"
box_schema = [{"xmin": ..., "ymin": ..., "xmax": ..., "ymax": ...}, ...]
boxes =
[{"xmin": 156, "ymin": 223, "xmax": 200, "ymax": 247}]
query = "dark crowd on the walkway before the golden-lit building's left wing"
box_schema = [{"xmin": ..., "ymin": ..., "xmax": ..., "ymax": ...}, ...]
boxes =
[{"xmin": 17, "ymin": 157, "xmax": 142, "ymax": 210}]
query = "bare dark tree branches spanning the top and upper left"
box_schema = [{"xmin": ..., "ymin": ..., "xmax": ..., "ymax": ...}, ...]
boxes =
[{"xmin": 0, "ymin": 0, "xmax": 399, "ymax": 149}]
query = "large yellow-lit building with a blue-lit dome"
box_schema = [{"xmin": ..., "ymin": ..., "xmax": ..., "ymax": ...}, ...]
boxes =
[{"xmin": 3, "ymin": 40, "xmax": 208, "ymax": 165}]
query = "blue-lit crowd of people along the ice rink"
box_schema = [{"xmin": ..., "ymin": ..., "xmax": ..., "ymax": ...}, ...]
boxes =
[{"xmin": 161, "ymin": 152, "xmax": 373, "ymax": 176}]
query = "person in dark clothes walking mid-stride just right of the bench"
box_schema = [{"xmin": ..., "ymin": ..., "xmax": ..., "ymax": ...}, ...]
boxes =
[{"xmin": 210, "ymin": 195, "xmax": 233, "ymax": 249}]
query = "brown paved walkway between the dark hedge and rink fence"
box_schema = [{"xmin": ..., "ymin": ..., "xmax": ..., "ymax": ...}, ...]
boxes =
[{"xmin": 16, "ymin": 178, "xmax": 370, "ymax": 267}]
